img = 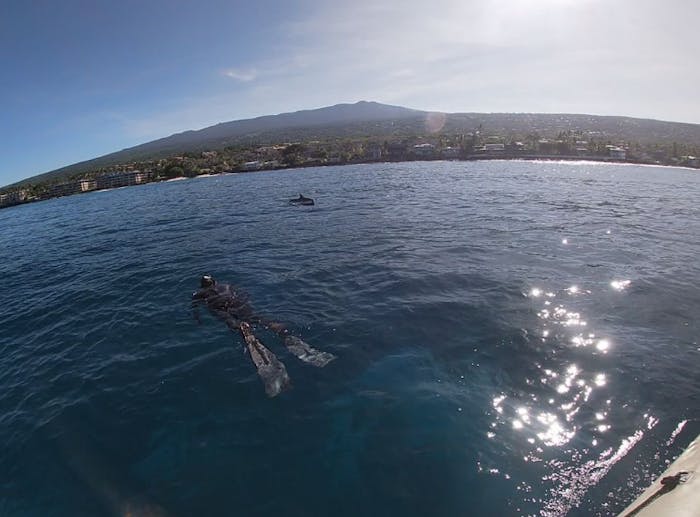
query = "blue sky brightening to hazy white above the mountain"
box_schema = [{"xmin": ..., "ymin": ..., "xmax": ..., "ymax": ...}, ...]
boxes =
[{"xmin": 0, "ymin": 0, "xmax": 700, "ymax": 185}]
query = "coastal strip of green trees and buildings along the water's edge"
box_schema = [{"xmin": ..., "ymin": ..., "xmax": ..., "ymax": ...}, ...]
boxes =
[{"xmin": 0, "ymin": 128, "xmax": 700, "ymax": 207}]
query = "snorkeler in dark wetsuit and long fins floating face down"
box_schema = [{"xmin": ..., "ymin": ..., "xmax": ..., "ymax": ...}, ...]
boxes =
[{"xmin": 192, "ymin": 275, "xmax": 335, "ymax": 397}]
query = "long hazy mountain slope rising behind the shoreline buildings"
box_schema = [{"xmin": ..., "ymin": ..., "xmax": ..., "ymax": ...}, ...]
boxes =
[{"xmin": 5, "ymin": 101, "xmax": 700, "ymax": 187}]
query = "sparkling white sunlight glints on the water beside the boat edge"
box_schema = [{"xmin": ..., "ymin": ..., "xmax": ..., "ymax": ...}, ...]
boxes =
[{"xmin": 487, "ymin": 280, "xmax": 658, "ymax": 516}]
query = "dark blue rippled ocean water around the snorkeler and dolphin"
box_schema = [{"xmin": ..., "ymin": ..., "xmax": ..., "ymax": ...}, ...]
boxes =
[{"xmin": 0, "ymin": 162, "xmax": 700, "ymax": 517}]
